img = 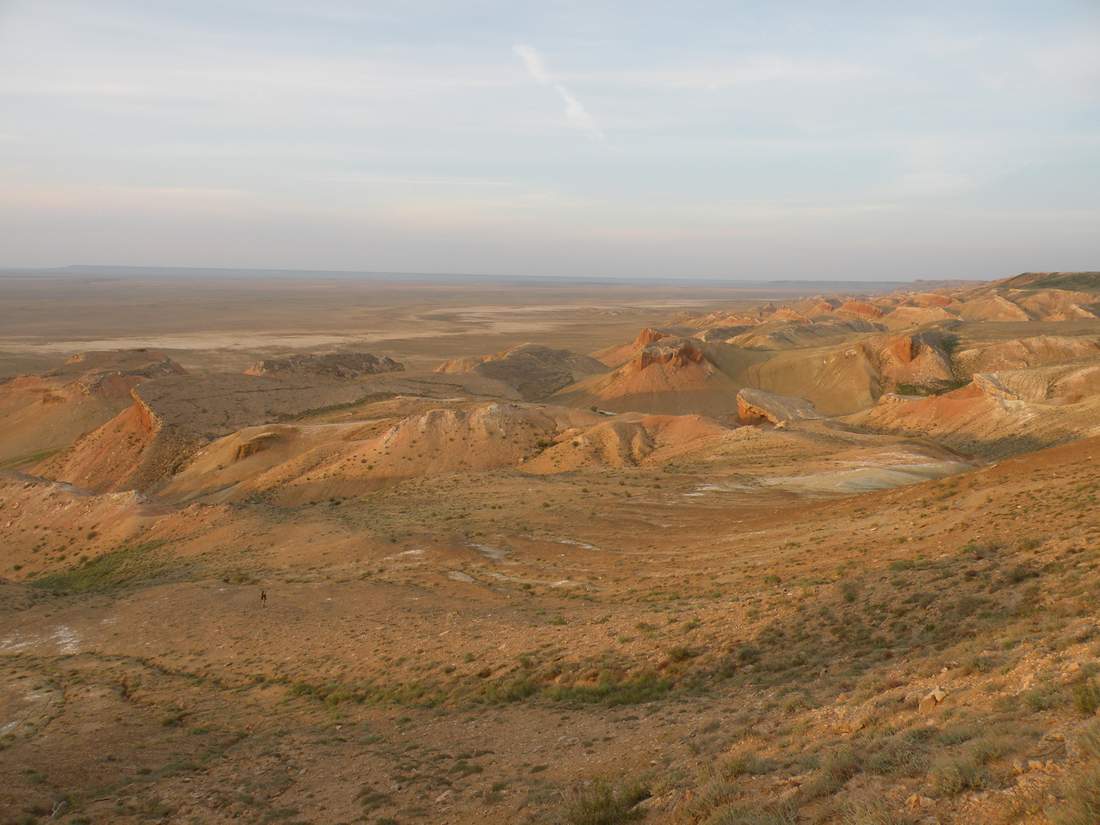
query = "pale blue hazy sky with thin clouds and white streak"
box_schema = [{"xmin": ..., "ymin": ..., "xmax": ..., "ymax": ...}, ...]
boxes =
[{"xmin": 0, "ymin": 0, "xmax": 1100, "ymax": 279}]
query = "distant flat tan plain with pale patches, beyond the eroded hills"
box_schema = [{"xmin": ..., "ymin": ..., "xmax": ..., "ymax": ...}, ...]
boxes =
[{"xmin": 0, "ymin": 267, "xmax": 910, "ymax": 377}]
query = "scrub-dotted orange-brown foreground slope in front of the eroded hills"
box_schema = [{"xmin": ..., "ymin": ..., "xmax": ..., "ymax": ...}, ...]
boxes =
[{"xmin": 0, "ymin": 428, "xmax": 1100, "ymax": 823}]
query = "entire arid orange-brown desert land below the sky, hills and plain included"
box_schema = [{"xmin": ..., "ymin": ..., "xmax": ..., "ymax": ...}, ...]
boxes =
[{"xmin": 0, "ymin": 268, "xmax": 1100, "ymax": 825}]
